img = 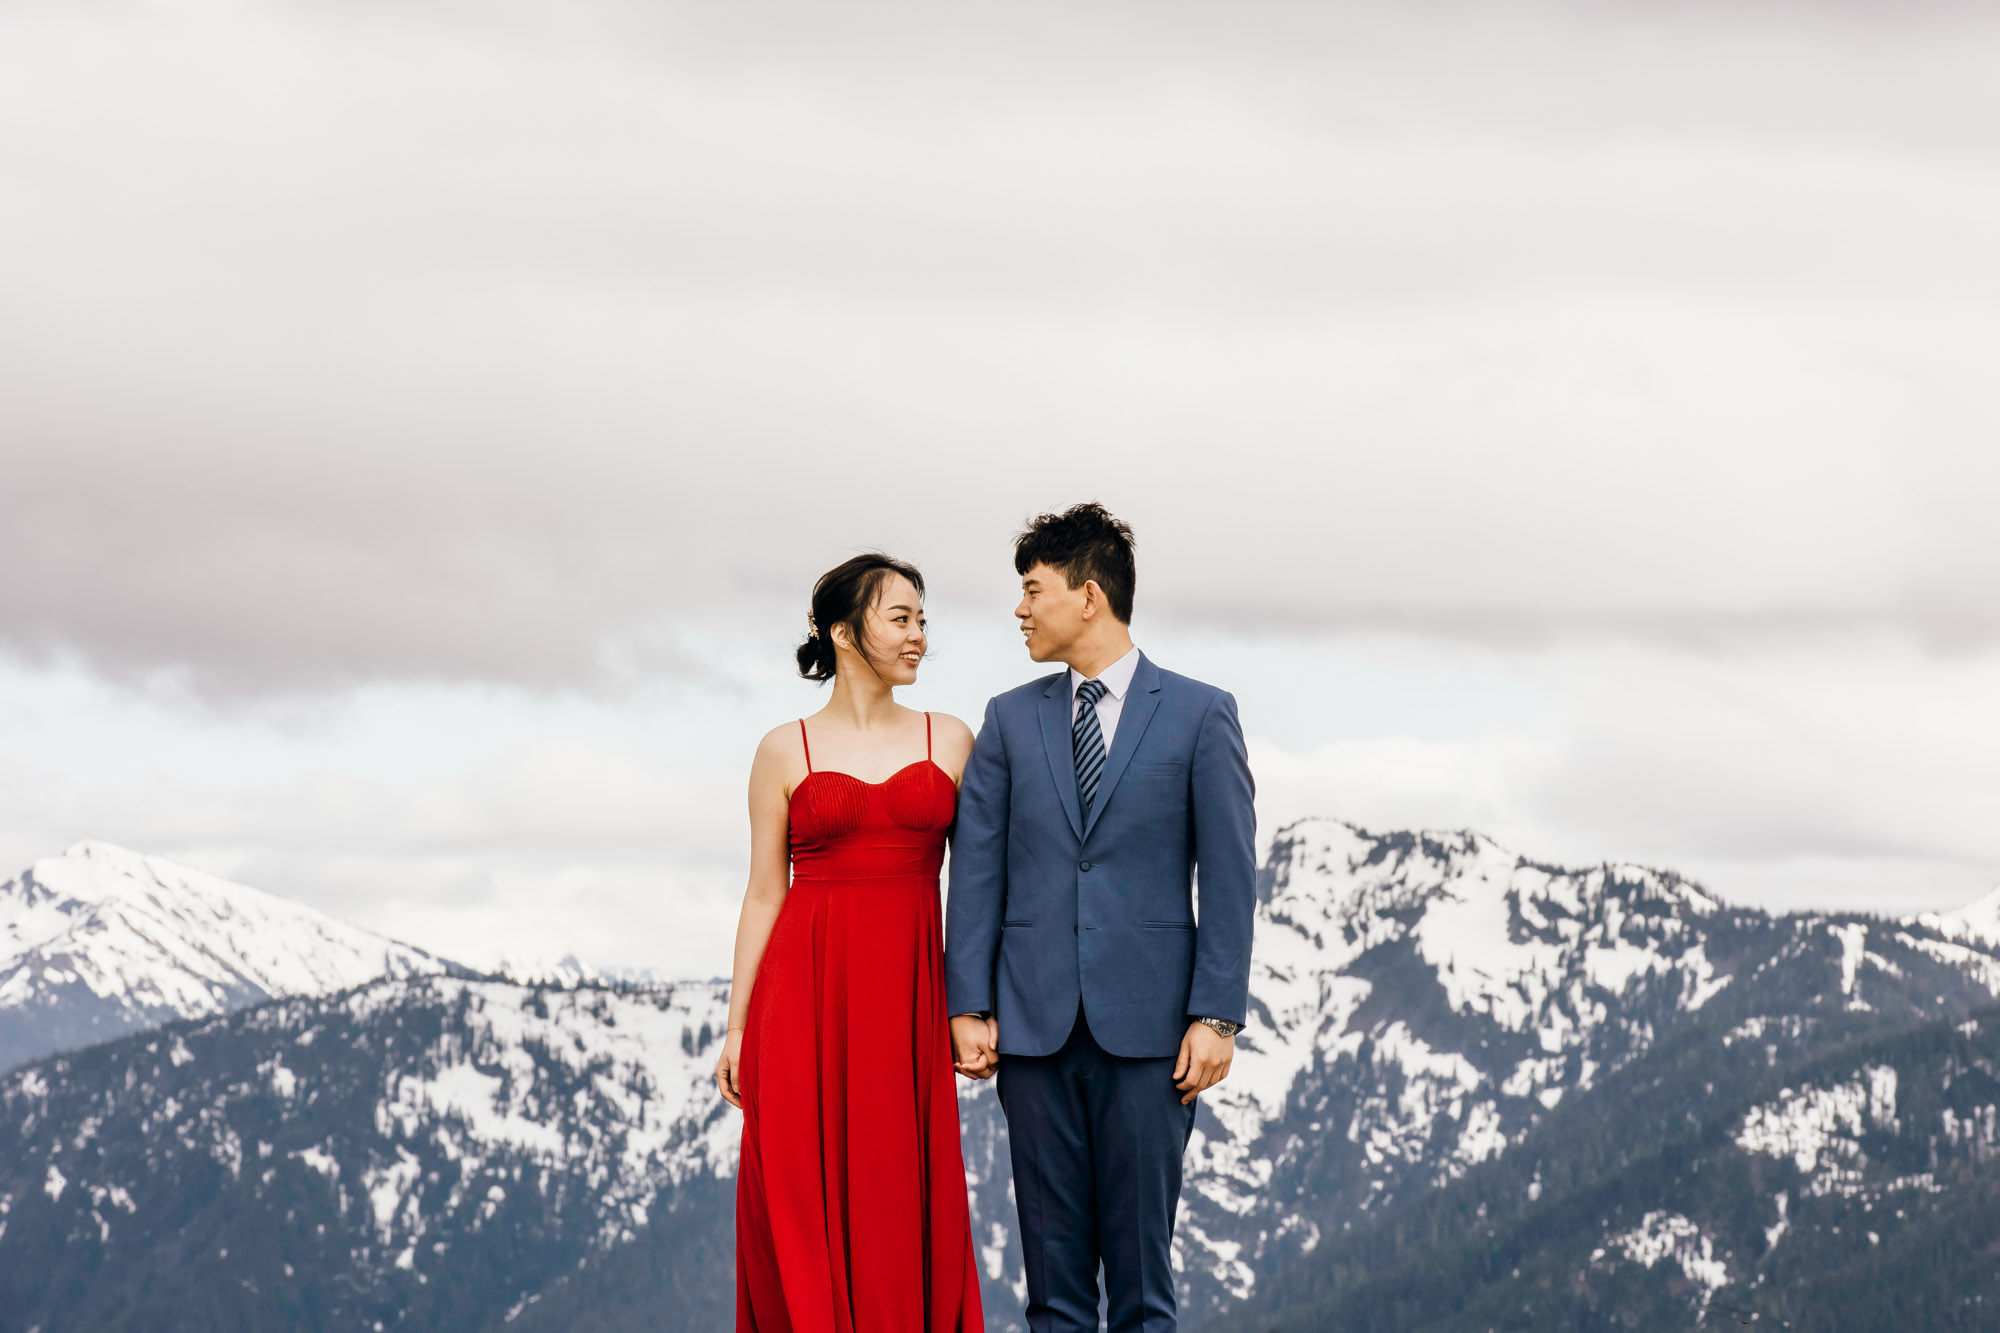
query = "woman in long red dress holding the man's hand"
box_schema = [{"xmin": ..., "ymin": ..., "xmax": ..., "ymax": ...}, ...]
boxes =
[{"xmin": 716, "ymin": 554, "xmax": 984, "ymax": 1333}]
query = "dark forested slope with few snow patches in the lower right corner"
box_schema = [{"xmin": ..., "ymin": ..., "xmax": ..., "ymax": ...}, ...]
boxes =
[{"xmin": 1248, "ymin": 1007, "xmax": 2000, "ymax": 1333}]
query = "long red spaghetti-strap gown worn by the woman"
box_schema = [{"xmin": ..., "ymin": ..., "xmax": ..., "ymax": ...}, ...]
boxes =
[{"xmin": 736, "ymin": 715, "xmax": 984, "ymax": 1333}]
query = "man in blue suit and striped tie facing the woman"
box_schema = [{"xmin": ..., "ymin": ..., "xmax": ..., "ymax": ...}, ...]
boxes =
[{"xmin": 944, "ymin": 504, "xmax": 1256, "ymax": 1333}]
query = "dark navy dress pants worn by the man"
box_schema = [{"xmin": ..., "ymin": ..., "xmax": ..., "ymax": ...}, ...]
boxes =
[{"xmin": 1000, "ymin": 1011, "xmax": 1194, "ymax": 1333}]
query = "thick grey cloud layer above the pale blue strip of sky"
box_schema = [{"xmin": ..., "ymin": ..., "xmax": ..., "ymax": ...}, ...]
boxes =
[{"xmin": 11, "ymin": 0, "xmax": 2000, "ymax": 695}]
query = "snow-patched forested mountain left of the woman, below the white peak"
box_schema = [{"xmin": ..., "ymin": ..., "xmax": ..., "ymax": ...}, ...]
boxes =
[{"xmin": 0, "ymin": 964, "xmax": 736, "ymax": 1329}]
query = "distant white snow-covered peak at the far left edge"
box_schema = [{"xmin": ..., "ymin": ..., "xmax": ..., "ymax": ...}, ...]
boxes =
[{"xmin": 0, "ymin": 843, "xmax": 462, "ymax": 1069}]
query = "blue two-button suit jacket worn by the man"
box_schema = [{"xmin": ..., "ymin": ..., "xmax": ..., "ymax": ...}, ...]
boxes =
[{"xmin": 944, "ymin": 654, "xmax": 1256, "ymax": 1057}]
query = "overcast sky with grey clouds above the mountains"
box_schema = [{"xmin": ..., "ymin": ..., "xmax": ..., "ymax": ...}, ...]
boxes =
[{"xmin": 0, "ymin": 0, "xmax": 2000, "ymax": 973}]
